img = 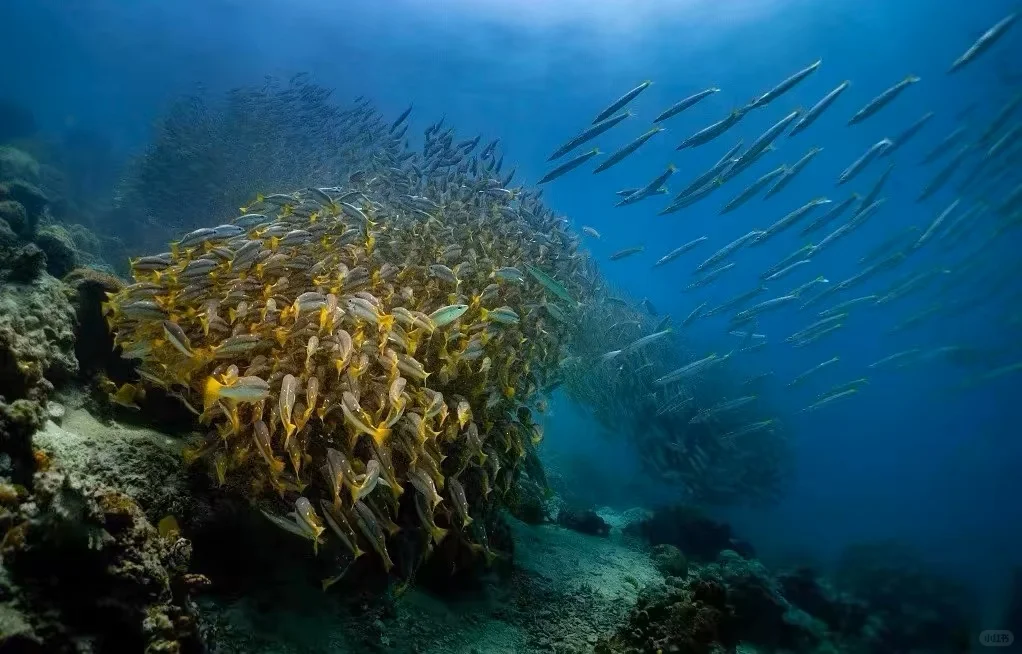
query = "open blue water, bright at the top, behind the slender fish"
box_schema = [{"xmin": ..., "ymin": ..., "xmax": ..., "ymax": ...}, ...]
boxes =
[{"xmin": 0, "ymin": 0, "xmax": 1022, "ymax": 617}]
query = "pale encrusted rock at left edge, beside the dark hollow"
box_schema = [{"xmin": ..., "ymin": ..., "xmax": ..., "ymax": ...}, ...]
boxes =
[{"xmin": 0, "ymin": 275, "xmax": 78, "ymax": 401}]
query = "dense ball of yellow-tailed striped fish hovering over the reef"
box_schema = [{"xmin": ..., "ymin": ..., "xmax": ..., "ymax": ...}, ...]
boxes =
[{"xmin": 104, "ymin": 100, "xmax": 592, "ymax": 586}]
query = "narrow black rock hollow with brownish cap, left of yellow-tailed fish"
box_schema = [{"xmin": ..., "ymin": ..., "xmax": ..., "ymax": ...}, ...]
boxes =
[{"xmin": 63, "ymin": 268, "xmax": 123, "ymax": 379}]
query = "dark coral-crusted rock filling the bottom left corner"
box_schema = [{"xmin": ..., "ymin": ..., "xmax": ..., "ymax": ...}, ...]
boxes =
[{"xmin": 2, "ymin": 472, "xmax": 202, "ymax": 652}]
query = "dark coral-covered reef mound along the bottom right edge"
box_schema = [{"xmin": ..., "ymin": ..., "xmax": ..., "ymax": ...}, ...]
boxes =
[{"xmin": 597, "ymin": 527, "xmax": 973, "ymax": 654}]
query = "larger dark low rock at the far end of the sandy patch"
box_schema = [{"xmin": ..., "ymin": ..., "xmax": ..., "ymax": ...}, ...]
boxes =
[{"xmin": 626, "ymin": 505, "xmax": 755, "ymax": 561}]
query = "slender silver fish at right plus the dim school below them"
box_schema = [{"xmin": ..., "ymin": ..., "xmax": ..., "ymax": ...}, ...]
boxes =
[{"xmin": 541, "ymin": 14, "xmax": 1022, "ymax": 486}]
